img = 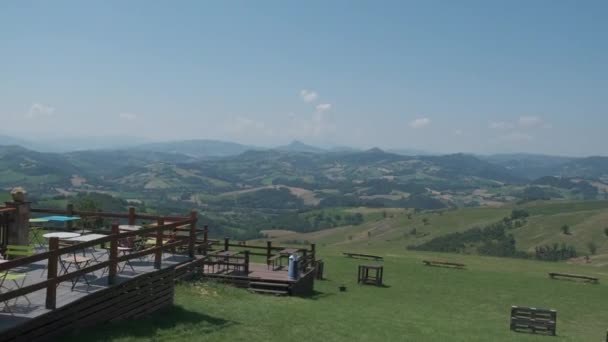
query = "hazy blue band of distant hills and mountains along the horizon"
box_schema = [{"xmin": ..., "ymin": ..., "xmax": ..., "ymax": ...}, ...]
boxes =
[{"xmin": 0, "ymin": 140, "xmax": 608, "ymax": 207}]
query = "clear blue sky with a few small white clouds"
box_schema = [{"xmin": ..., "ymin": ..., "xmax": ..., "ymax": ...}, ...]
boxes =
[{"xmin": 0, "ymin": 0, "xmax": 608, "ymax": 156}]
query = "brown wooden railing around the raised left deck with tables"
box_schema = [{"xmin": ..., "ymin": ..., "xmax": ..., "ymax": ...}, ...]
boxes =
[{"xmin": 0, "ymin": 209, "xmax": 198, "ymax": 309}]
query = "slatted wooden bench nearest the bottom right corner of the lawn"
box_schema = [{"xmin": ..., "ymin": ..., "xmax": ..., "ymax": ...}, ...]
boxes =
[{"xmin": 511, "ymin": 306, "xmax": 557, "ymax": 336}]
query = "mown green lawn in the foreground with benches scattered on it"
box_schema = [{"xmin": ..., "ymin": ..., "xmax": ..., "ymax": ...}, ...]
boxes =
[{"xmin": 63, "ymin": 251, "xmax": 608, "ymax": 342}]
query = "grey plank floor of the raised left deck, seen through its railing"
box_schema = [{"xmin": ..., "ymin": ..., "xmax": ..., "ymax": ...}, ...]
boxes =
[{"xmin": 0, "ymin": 250, "xmax": 190, "ymax": 332}]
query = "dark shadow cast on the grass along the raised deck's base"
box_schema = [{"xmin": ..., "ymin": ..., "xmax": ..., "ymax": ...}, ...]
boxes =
[{"xmin": 59, "ymin": 305, "xmax": 238, "ymax": 342}]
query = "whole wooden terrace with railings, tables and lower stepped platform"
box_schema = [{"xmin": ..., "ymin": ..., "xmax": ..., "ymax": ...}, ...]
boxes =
[{"xmin": 0, "ymin": 203, "xmax": 315, "ymax": 342}]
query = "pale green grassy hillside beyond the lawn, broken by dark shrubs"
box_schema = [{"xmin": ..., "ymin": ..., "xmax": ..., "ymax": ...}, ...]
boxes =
[{"xmin": 263, "ymin": 201, "xmax": 608, "ymax": 267}]
